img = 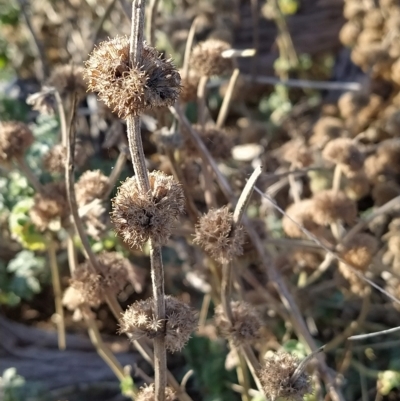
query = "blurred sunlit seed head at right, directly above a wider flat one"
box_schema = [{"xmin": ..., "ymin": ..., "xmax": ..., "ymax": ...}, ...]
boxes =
[{"xmin": 322, "ymin": 138, "xmax": 364, "ymax": 171}]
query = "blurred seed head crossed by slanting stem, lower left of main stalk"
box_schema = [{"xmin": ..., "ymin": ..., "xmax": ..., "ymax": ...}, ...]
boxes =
[{"xmin": 70, "ymin": 252, "xmax": 130, "ymax": 307}]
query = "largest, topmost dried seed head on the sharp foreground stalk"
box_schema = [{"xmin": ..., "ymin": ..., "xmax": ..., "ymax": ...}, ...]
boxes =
[{"xmin": 84, "ymin": 36, "xmax": 181, "ymax": 118}]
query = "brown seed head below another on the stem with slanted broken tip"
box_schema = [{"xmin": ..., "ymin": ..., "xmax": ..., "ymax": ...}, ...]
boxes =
[{"xmin": 214, "ymin": 301, "xmax": 261, "ymax": 346}]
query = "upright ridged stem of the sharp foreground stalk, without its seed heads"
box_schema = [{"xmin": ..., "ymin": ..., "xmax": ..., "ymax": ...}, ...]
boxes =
[{"xmin": 127, "ymin": 0, "xmax": 167, "ymax": 401}]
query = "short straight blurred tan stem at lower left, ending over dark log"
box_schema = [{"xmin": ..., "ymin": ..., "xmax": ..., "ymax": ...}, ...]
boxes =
[{"xmin": 47, "ymin": 236, "xmax": 66, "ymax": 350}]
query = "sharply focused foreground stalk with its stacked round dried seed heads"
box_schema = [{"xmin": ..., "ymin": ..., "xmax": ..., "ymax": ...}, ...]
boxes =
[{"xmin": 85, "ymin": 0, "xmax": 196, "ymax": 401}]
